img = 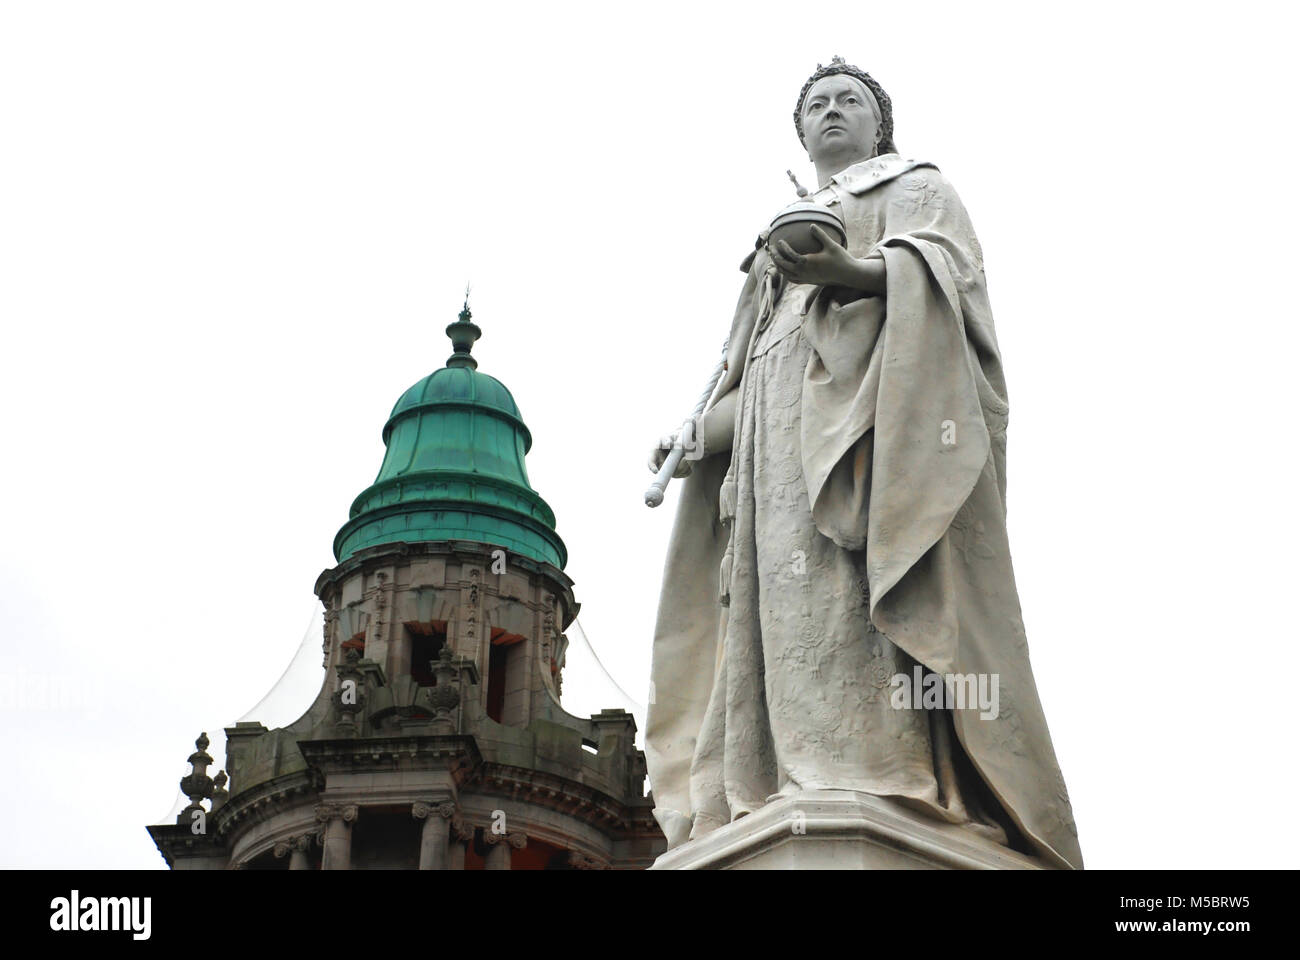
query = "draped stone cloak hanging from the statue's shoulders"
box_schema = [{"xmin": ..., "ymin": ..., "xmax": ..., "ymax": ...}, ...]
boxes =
[{"xmin": 646, "ymin": 153, "xmax": 1083, "ymax": 868}]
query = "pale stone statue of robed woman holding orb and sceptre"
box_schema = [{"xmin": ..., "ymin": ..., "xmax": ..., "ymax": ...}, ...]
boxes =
[{"xmin": 646, "ymin": 57, "xmax": 1083, "ymax": 868}]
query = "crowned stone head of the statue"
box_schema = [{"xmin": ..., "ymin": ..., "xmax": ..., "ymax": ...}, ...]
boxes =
[{"xmin": 794, "ymin": 57, "xmax": 897, "ymax": 161}]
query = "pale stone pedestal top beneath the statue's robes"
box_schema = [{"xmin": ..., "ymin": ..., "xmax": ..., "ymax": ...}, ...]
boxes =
[{"xmin": 650, "ymin": 790, "xmax": 1047, "ymax": 870}]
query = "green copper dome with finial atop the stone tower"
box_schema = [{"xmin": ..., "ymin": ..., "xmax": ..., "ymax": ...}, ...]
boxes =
[{"xmin": 334, "ymin": 303, "xmax": 568, "ymax": 568}]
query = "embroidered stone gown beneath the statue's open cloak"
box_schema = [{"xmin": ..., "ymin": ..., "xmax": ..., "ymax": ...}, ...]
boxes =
[{"xmin": 690, "ymin": 192, "xmax": 1006, "ymax": 843}]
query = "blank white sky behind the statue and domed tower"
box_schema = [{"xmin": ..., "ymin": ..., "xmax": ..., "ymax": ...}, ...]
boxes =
[{"xmin": 0, "ymin": 0, "xmax": 1300, "ymax": 868}]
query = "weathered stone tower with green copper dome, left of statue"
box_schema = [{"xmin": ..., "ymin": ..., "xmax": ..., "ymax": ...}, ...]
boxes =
[{"xmin": 148, "ymin": 304, "xmax": 664, "ymax": 870}]
